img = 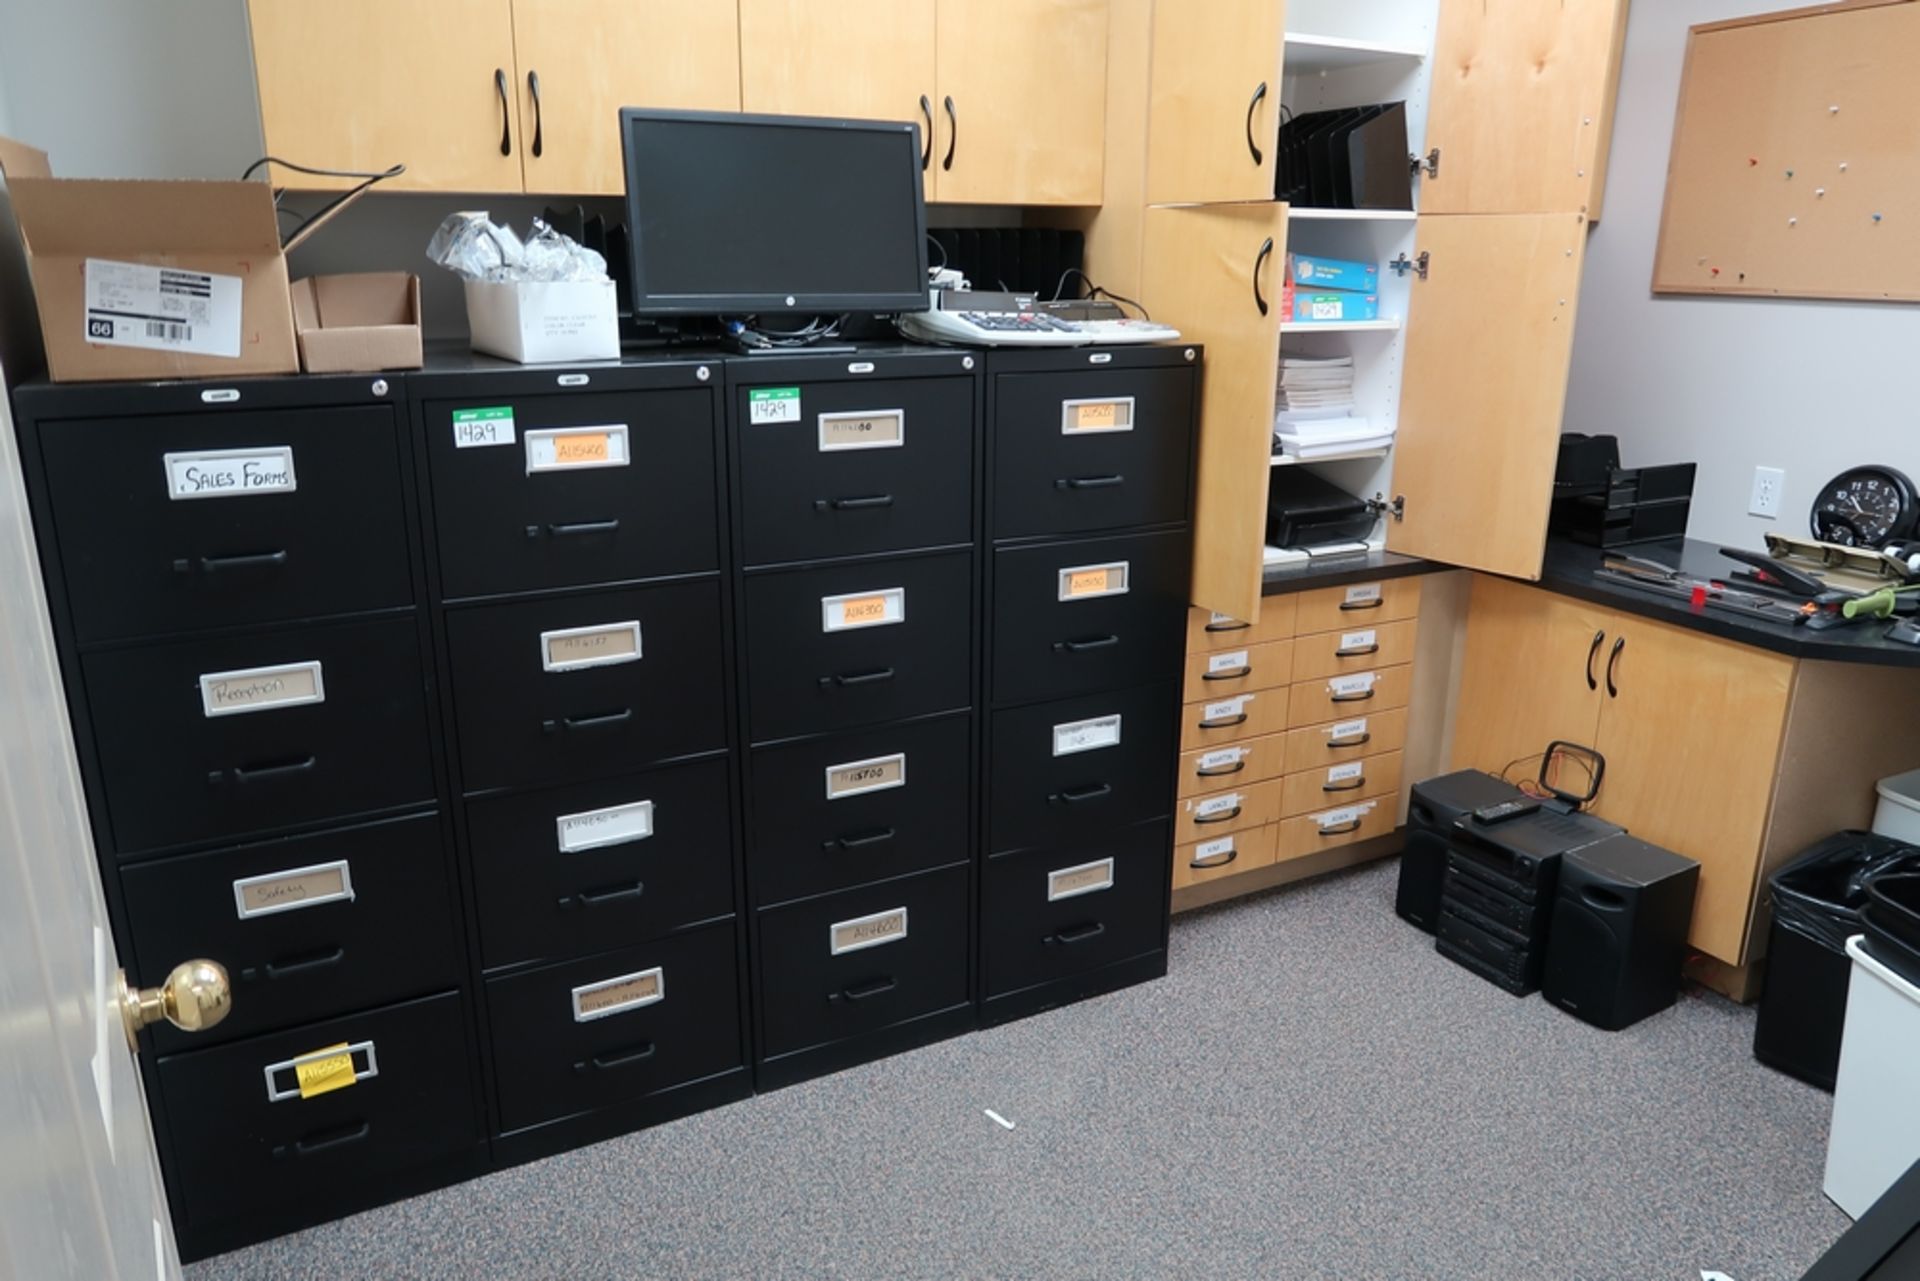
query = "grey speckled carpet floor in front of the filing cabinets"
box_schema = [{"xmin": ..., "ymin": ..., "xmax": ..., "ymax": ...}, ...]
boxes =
[{"xmin": 186, "ymin": 862, "xmax": 1847, "ymax": 1281}]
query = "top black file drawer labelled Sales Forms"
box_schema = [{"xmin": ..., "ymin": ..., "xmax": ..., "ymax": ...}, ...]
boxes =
[{"xmin": 40, "ymin": 405, "xmax": 413, "ymax": 641}]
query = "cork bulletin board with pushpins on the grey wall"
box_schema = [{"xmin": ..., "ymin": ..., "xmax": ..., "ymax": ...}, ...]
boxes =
[{"xmin": 1653, "ymin": 0, "xmax": 1920, "ymax": 302}]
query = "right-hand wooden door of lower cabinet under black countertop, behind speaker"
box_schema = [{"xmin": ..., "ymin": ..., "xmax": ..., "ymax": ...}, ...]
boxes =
[{"xmin": 1596, "ymin": 615, "xmax": 1793, "ymax": 966}]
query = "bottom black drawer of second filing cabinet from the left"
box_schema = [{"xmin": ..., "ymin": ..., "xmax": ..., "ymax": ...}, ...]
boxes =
[{"xmin": 486, "ymin": 924, "xmax": 745, "ymax": 1133}]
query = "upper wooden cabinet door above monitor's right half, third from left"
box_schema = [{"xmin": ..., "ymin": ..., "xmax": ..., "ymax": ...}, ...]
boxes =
[{"xmin": 739, "ymin": 0, "xmax": 939, "ymax": 200}]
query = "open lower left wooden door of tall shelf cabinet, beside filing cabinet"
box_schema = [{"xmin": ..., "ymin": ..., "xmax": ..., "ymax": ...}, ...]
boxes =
[{"xmin": 1140, "ymin": 202, "xmax": 1286, "ymax": 622}]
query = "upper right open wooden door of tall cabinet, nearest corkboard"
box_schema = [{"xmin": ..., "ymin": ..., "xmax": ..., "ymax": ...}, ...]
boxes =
[{"xmin": 1421, "ymin": 0, "xmax": 1626, "ymax": 217}]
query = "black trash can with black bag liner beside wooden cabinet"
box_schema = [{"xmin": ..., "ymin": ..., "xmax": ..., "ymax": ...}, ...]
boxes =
[{"xmin": 1753, "ymin": 832, "xmax": 1920, "ymax": 1091}]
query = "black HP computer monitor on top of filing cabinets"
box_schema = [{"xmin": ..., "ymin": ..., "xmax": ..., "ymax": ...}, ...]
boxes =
[{"xmin": 620, "ymin": 108, "xmax": 927, "ymax": 317}]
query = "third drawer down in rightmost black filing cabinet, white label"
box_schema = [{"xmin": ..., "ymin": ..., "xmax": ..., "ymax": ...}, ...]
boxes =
[{"xmin": 987, "ymin": 686, "xmax": 1177, "ymax": 851}]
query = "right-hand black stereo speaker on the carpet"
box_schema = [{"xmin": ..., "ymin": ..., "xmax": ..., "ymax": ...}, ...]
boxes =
[{"xmin": 1540, "ymin": 834, "xmax": 1699, "ymax": 1031}]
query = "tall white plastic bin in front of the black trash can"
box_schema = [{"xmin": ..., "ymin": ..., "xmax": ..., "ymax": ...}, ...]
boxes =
[{"xmin": 1824, "ymin": 933, "xmax": 1920, "ymax": 1218}]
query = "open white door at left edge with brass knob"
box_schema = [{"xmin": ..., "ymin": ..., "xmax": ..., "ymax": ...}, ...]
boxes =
[{"xmin": 0, "ymin": 361, "xmax": 184, "ymax": 1281}]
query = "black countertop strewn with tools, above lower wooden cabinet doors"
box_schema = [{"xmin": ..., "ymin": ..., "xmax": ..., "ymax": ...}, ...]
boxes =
[{"xmin": 1540, "ymin": 538, "xmax": 1920, "ymax": 668}]
